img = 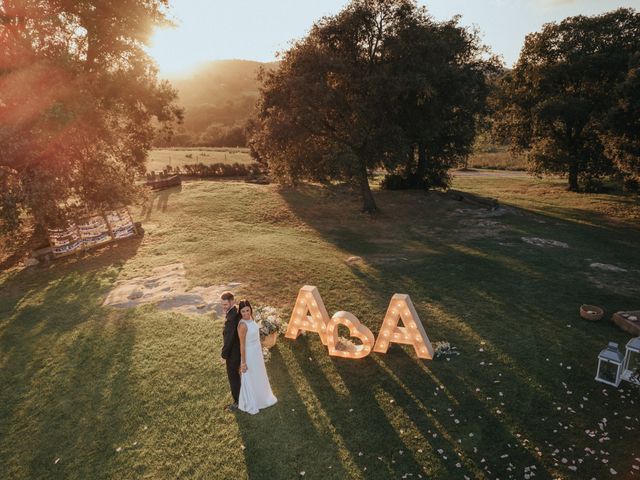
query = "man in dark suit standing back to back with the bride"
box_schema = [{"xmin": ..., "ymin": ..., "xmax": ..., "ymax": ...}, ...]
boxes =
[{"xmin": 220, "ymin": 292, "xmax": 240, "ymax": 411}]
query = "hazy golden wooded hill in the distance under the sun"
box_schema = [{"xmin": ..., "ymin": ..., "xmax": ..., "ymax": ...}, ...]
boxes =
[{"xmin": 156, "ymin": 60, "xmax": 277, "ymax": 147}]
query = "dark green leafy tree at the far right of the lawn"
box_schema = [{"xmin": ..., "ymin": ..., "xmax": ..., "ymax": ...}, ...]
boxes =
[{"xmin": 498, "ymin": 8, "xmax": 640, "ymax": 191}]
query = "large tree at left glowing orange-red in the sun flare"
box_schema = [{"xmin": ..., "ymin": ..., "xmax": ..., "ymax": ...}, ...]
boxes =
[{"xmin": 0, "ymin": 0, "xmax": 182, "ymax": 231}]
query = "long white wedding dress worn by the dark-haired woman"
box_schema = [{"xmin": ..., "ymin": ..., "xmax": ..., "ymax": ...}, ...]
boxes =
[{"xmin": 238, "ymin": 320, "xmax": 278, "ymax": 415}]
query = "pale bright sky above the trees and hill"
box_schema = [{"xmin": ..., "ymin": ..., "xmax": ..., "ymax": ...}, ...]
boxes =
[{"xmin": 150, "ymin": 0, "xmax": 640, "ymax": 76}]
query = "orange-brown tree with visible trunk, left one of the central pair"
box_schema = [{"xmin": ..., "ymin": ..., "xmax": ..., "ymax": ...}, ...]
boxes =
[{"xmin": 249, "ymin": 0, "xmax": 416, "ymax": 213}]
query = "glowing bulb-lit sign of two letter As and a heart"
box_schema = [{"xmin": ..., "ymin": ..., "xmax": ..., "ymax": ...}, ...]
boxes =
[{"xmin": 285, "ymin": 285, "xmax": 433, "ymax": 360}]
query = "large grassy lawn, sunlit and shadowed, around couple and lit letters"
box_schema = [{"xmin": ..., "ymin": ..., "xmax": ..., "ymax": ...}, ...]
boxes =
[{"xmin": 0, "ymin": 176, "xmax": 640, "ymax": 479}]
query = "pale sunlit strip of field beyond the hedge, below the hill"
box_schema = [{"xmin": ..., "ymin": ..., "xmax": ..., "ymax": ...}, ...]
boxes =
[{"xmin": 147, "ymin": 148, "xmax": 254, "ymax": 172}]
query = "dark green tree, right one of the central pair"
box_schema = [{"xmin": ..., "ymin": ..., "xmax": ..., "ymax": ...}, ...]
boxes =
[{"xmin": 389, "ymin": 15, "xmax": 500, "ymax": 188}]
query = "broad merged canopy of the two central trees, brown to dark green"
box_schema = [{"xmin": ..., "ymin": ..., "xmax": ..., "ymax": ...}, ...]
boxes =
[{"xmin": 249, "ymin": 0, "xmax": 495, "ymax": 212}]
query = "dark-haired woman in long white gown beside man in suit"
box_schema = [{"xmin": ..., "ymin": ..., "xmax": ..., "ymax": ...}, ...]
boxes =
[{"xmin": 238, "ymin": 300, "xmax": 278, "ymax": 415}]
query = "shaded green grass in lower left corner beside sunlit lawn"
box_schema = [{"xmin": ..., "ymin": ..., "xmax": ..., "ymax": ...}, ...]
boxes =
[{"xmin": 0, "ymin": 264, "xmax": 142, "ymax": 478}]
